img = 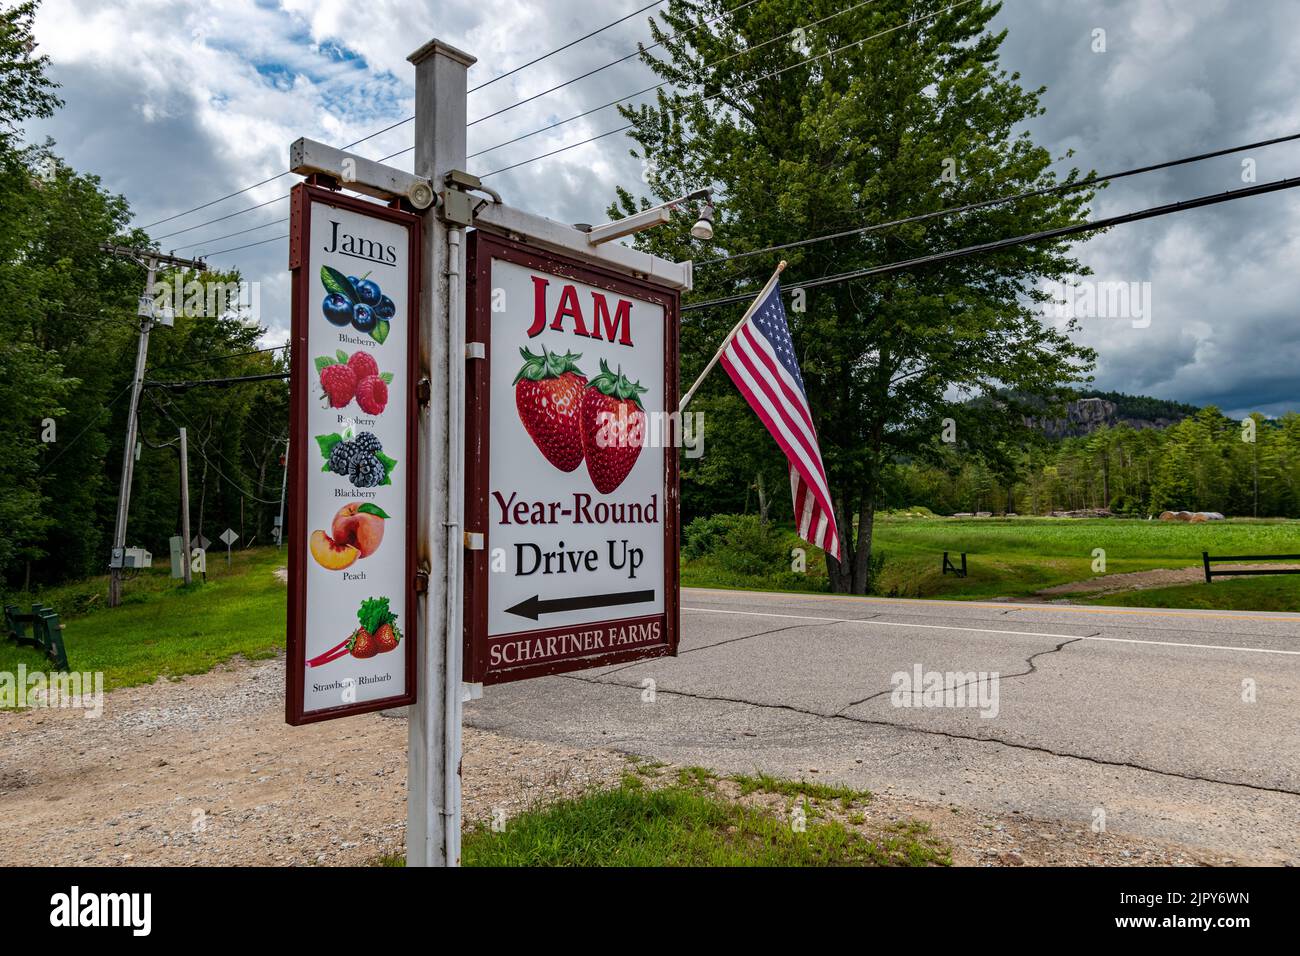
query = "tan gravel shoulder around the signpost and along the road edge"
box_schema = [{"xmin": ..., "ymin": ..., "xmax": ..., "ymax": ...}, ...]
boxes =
[{"xmin": 0, "ymin": 658, "xmax": 1256, "ymax": 866}]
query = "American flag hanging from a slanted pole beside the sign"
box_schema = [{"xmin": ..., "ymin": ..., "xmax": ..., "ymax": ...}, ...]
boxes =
[{"xmin": 720, "ymin": 282, "xmax": 841, "ymax": 558}]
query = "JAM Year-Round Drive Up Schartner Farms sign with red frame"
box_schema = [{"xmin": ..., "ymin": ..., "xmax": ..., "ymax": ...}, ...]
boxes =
[{"xmin": 465, "ymin": 233, "xmax": 677, "ymax": 683}]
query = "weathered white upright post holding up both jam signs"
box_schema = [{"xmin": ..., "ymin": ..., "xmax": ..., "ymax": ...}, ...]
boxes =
[{"xmin": 407, "ymin": 40, "xmax": 475, "ymax": 866}]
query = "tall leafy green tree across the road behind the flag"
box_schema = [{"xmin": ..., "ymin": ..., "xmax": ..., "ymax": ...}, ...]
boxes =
[{"xmin": 611, "ymin": 0, "xmax": 1093, "ymax": 593}]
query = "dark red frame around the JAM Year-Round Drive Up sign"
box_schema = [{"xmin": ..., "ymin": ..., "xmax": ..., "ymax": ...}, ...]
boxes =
[{"xmin": 464, "ymin": 230, "xmax": 681, "ymax": 684}]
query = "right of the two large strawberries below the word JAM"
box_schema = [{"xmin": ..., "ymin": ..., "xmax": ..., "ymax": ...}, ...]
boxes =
[{"xmin": 581, "ymin": 359, "xmax": 647, "ymax": 494}]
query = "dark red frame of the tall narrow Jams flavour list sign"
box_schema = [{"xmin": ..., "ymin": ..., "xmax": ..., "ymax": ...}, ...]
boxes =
[{"xmin": 281, "ymin": 182, "xmax": 423, "ymax": 726}]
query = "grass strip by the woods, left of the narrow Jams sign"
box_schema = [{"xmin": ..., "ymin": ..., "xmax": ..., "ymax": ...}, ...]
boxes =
[{"xmin": 0, "ymin": 548, "xmax": 286, "ymax": 689}]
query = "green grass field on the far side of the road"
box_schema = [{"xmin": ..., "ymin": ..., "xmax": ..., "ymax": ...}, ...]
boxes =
[{"xmin": 681, "ymin": 516, "xmax": 1300, "ymax": 610}]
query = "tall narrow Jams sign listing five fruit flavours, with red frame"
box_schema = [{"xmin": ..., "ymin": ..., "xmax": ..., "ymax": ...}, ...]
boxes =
[{"xmin": 286, "ymin": 186, "xmax": 419, "ymax": 723}]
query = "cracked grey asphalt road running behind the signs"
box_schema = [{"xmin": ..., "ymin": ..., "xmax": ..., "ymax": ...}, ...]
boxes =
[{"xmin": 465, "ymin": 589, "xmax": 1300, "ymax": 865}]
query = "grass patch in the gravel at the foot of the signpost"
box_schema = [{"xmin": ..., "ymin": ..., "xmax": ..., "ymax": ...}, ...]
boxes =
[{"xmin": 454, "ymin": 767, "xmax": 950, "ymax": 866}]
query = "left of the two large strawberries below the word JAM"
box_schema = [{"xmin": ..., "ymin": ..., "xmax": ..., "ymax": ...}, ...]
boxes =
[{"xmin": 515, "ymin": 346, "xmax": 586, "ymax": 471}]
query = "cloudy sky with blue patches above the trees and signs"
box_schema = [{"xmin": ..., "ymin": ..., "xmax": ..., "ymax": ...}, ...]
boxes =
[{"xmin": 29, "ymin": 0, "xmax": 1300, "ymax": 414}]
